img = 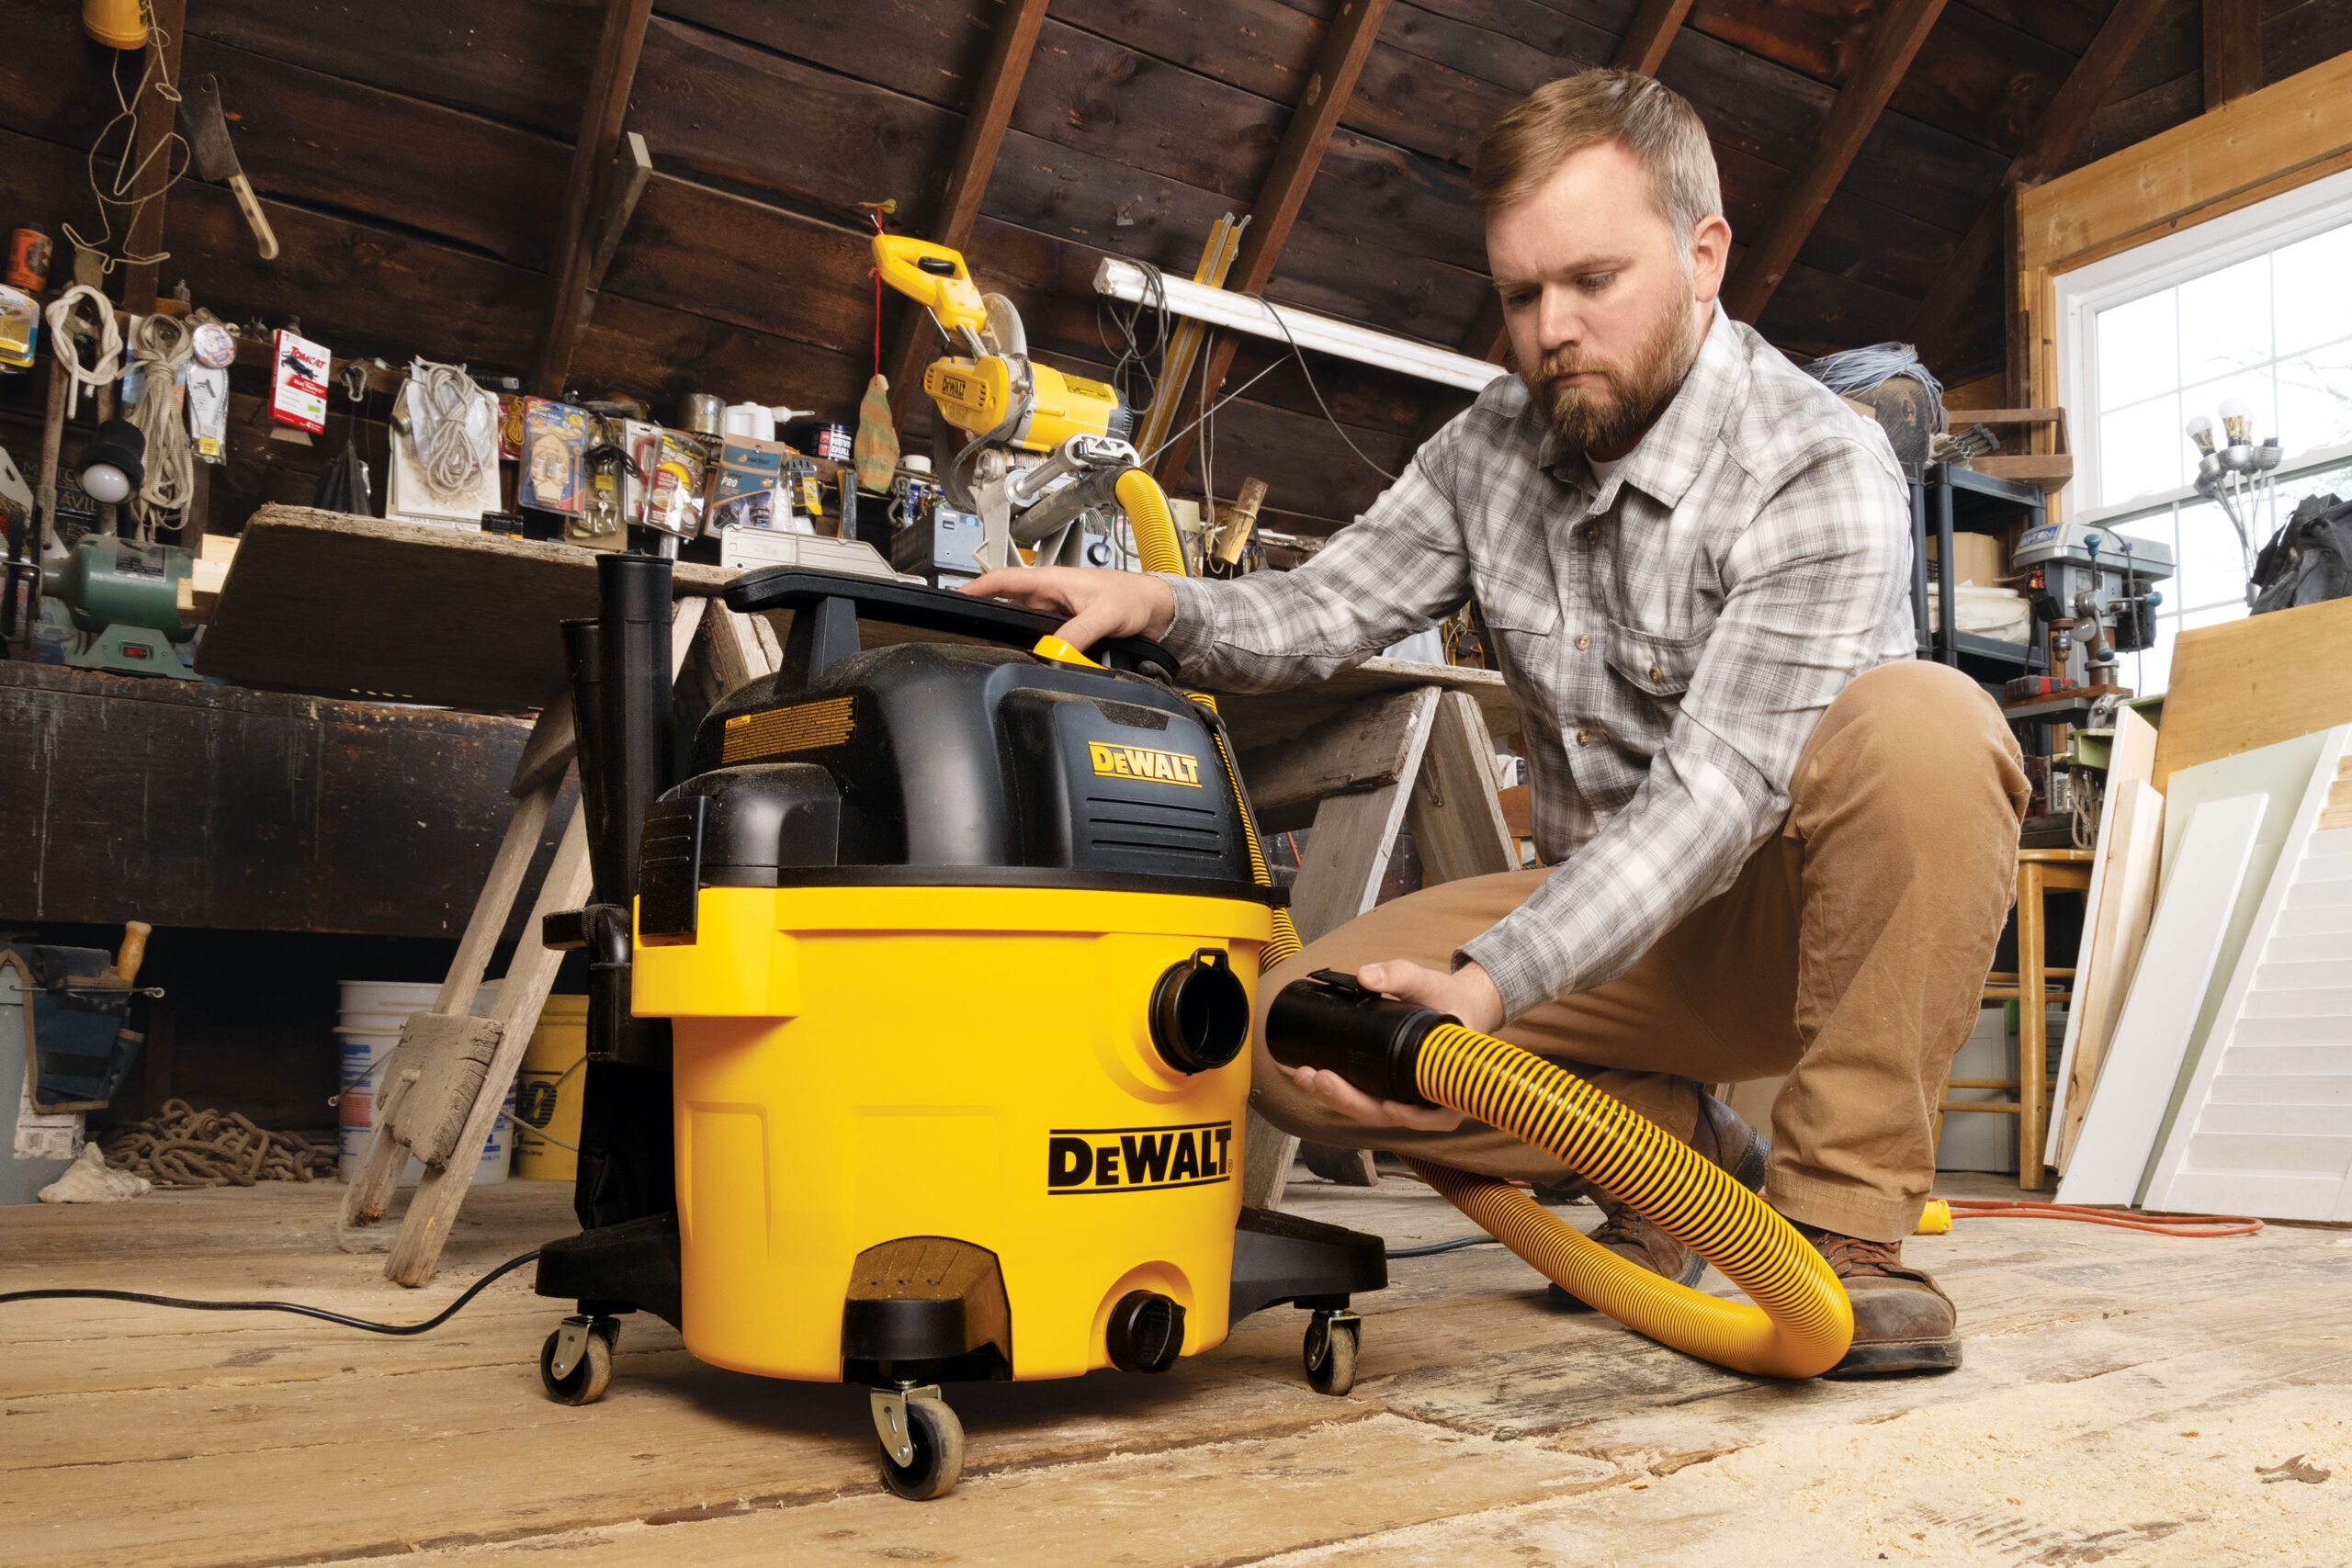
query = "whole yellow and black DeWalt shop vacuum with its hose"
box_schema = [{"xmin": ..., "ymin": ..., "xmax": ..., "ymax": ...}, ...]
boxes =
[{"xmin": 537, "ymin": 545, "xmax": 1853, "ymax": 1497}]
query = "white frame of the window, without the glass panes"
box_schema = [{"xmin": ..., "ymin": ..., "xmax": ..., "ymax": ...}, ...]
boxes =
[{"xmin": 2051, "ymin": 169, "xmax": 2352, "ymax": 522}]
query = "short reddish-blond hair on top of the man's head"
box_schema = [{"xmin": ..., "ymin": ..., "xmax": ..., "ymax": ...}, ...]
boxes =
[{"xmin": 1470, "ymin": 71, "xmax": 1724, "ymax": 249}]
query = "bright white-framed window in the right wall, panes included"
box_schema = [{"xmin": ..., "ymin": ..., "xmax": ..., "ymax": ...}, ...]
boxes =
[{"xmin": 2058, "ymin": 174, "xmax": 2352, "ymax": 691}]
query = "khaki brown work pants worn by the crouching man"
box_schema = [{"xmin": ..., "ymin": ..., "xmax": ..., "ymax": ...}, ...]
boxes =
[{"xmin": 1251, "ymin": 663, "xmax": 2034, "ymax": 1241}]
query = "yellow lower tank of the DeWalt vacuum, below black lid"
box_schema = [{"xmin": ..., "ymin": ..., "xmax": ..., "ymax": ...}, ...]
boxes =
[{"xmin": 638, "ymin": 888, "xmax": 1268, "ymax": 1382}]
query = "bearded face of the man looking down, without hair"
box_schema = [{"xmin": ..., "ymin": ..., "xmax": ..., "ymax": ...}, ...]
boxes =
[{"xmin": 1487, "ymin": 141, "xmax": 1731, "ymax": 458}]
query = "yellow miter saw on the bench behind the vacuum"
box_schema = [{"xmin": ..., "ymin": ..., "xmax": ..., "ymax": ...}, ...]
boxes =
[{"xmin": 875, "ymin": 235, "xmax": 1181, "ymax": 571}]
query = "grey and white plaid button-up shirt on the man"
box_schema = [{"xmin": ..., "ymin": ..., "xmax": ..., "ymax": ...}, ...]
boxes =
[{"xmin": 1164, "ymin": 308, "xmax": 1912, "ymax": 1018}]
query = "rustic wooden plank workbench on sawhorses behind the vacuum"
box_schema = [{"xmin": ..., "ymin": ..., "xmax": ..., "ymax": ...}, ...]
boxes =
[{"xmin": 198, "ymin": 508, "xmax": 1517, "ymax": 1286}]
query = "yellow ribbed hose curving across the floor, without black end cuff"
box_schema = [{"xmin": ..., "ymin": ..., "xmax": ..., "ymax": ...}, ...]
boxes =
[{"xmin": 1407, "ymin": 1022, "xmax": 1853, "ymax": 1378}]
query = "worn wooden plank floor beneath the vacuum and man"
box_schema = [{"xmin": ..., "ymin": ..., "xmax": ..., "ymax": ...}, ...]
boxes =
[{"xmin": 0, "ymin": 1180, "xmax": 2352, "ymax": 1568}]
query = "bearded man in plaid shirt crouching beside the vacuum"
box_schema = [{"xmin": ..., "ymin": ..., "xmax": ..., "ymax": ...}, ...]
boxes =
[{"xmin": 967, "ymin": 71, "xmax": 2037, "ymax": 1375}]
